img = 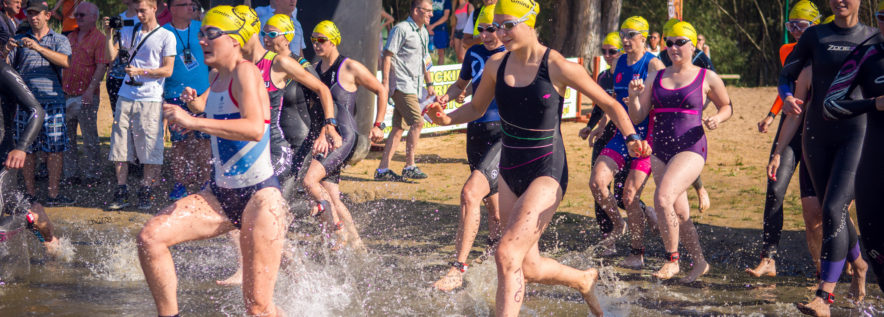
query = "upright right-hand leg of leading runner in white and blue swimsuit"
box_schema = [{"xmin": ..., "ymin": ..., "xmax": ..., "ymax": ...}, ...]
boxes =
[{"xmin": 240, "ymin": 188, "xmax": 288, "ymax": 316}]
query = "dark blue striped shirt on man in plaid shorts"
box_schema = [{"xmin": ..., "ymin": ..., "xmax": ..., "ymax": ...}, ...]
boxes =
[{"xmin": 9, "ymin": 30, "xmax": 71, "ymax": 104}]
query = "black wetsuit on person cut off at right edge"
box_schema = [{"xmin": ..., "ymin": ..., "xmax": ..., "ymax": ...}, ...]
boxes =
[{"xmin": 823, "ymin": 34, "xmax": 884, "ymax": 289}]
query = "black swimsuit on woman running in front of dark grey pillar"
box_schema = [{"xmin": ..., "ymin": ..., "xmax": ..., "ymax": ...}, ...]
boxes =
[{"xmin": 305, "ymin": 56, "xmax": 357, "ymax": 183}]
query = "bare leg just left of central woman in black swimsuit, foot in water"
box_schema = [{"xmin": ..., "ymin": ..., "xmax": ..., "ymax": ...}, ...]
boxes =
[{"xmin": 433, "ymin": 171, "xmax": 491, "ymax": 291}]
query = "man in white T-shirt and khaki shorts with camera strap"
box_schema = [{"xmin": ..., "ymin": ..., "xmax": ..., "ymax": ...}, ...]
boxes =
[{"xmin": 104, "ymin": 0, "xmax": 177, "ymax": 210}]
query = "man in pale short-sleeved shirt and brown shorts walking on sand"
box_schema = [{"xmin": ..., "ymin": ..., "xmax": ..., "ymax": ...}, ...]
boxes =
[{"xmin": 374, "ymin": 0, "xmax": 436, "ymax": 181}]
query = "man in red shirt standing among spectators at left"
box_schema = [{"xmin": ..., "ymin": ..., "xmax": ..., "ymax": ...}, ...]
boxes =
[{"xmin": 62, "ymin": 2, "xmax": 109, "ymax": 184}]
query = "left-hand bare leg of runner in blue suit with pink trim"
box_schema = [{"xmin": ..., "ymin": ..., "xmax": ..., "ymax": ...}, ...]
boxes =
[{"xmin": 589, "ymin": 156, "xmax": 626, "ymax": 256}]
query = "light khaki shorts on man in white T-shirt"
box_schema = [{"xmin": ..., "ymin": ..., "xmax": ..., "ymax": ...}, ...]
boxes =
[{"xmin": 108, "ymin": 97, "xmax": 164, "ymax": 165}]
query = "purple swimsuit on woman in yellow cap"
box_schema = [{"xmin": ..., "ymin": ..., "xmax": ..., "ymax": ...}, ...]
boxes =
[{"xmin": 648, "ymin": 68, "xmax": 706, "ymax": 164}]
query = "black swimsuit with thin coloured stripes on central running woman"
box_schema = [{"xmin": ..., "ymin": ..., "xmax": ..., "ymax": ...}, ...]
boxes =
[{"xmin": 494, "ymin": 48, "xmax": 568, "ymax": 197}]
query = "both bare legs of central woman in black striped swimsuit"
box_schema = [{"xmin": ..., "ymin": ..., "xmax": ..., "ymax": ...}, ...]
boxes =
[{"xmin": 495, "ymin": 177, "xmax": 602, "ymax": 316}]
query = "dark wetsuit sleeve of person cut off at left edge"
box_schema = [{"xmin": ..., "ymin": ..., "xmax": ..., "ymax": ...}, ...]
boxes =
[{"xmin": 0, "ymin": 61, "xmax": 46, "ymax": 151}]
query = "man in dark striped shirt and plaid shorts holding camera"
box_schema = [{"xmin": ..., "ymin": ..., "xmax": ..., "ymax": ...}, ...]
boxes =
[{"xmin": 9, "ymin": 0, "xmax": 74, "ymax": 206}]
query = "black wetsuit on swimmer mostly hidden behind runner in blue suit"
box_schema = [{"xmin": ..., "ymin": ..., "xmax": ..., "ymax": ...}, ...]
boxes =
[{"xmin": 586, "ymin": 71, "xmax": 648, "ymax": 234}]
